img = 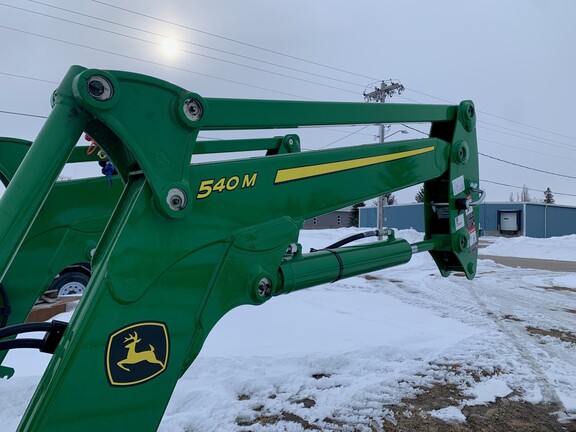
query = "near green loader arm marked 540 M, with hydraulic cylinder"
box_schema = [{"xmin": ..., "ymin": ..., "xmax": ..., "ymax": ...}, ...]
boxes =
[{"xmin": 0, "ymin": 66, "xmax": 481, "ymax": 432}]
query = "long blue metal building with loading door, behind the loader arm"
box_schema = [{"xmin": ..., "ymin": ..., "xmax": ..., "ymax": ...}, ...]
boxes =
[{"xmin": 359, "ymin": 202, "xmax": 576, "ymax": 238}]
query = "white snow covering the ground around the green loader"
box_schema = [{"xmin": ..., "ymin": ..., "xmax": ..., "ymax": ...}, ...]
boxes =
[{"xmin": 0, "ymin": 229, "xmax": 576, "ymax": 432}]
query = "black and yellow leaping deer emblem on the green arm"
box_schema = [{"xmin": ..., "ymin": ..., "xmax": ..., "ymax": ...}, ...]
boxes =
[{"xmin": 106, "ymin": 321, "xmax": 170, "ymax": 386}]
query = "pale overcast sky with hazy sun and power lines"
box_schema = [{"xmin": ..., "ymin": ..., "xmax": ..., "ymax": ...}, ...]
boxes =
[{"xmin": 0, "ymin": 0, "xmax": 576, "ymax": 205}]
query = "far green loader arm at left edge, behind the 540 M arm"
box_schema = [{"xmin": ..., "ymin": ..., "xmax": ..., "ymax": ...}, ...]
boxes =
[{"xmin": 0, "ymin": 137, "xmax": 123, "ymax": 377}]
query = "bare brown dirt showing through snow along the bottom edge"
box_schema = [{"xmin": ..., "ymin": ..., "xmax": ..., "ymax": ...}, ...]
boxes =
[{"xmin": 236, "ymin": 370, "xmax": 576, "ymax": 432}]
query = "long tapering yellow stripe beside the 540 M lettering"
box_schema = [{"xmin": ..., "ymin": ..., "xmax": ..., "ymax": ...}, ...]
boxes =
[{"xmin": 274, "ymin": 146, "xmax": 435, "ymax": 184}]
